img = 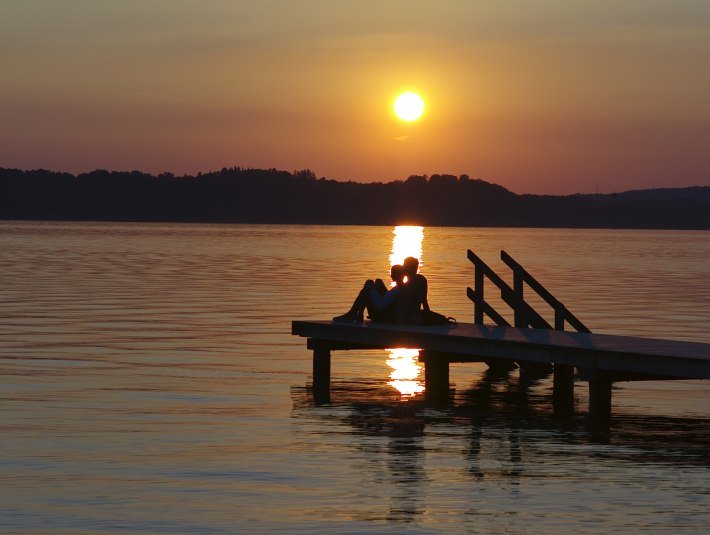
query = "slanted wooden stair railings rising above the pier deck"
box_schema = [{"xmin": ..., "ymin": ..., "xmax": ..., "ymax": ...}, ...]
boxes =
[{"xmin": 466, "ymin": 249, "xmax": 591, "ymax": 333}]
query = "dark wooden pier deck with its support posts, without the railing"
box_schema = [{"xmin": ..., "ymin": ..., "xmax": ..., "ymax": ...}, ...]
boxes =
[{"xmin": 292, "ymin": 321, "xmax": 710, "ymax": 419}]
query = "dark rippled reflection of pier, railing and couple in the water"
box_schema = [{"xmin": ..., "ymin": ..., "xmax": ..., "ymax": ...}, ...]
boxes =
[{"xmin": 291, "ymin": 370, "xmax": 710, "ymax": 522}]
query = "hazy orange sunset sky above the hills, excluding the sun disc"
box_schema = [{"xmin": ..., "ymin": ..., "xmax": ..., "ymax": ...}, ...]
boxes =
[{"xmin": 0, "ymin": 0, "xmax": 710, "ymax": 193}]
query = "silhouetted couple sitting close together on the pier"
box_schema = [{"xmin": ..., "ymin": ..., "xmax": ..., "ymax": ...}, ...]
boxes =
[{"xmin": 333, "ymin": 256, "xmax": 429, "ymax": 324}]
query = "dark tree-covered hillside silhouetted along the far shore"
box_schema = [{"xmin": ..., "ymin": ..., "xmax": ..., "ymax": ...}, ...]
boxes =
[{"xmin": 0, "ymin": 167, "xmax": 710, "ymax": 229}]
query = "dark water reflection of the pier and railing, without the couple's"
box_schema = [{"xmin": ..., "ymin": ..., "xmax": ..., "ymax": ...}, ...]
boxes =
[{"xmin": 291, "ymin": 369, "xmax": 710, "ymax": 474}]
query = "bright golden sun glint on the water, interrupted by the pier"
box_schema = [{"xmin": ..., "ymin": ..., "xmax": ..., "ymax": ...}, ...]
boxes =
[{"xmin": 387, "ymin": 225, "xmax": 424, "ymax": 397}]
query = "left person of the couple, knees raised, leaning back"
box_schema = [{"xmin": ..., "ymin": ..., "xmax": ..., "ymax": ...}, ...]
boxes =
[{"xmin": 333, "ymin": 264, "xmax": 404, "ymax": 323}]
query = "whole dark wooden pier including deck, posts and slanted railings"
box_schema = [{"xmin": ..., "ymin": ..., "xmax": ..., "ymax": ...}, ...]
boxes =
[{"xmin": 292, "ymin": 251, "xmax": 710, "ymax": 420}]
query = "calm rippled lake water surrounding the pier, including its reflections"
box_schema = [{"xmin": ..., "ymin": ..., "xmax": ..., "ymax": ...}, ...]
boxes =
[{"xmin": 0, "ymin": 222, "xmax": 710, "ymax": 533}]
